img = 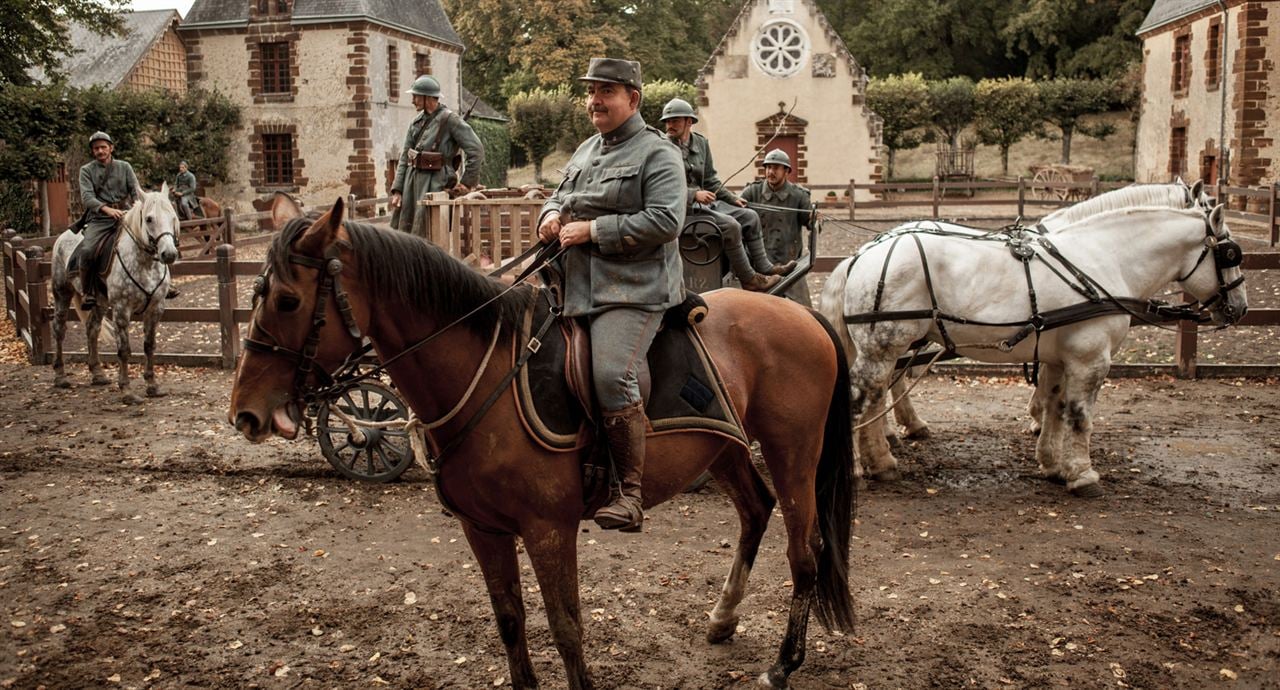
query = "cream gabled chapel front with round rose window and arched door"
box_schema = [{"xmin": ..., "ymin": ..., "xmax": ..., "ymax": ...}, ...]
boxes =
[{"xmin": 696, "ymin": 0, "xmax": 882, "ymax": 193}]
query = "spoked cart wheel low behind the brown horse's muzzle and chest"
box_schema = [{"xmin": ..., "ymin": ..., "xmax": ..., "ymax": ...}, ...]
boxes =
[{"xmin": 316, "ymin": 380, "xmax": 413, "ymax": 484}]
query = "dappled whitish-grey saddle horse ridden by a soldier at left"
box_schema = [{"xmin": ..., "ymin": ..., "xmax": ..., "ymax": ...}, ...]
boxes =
[{"xmin": 52, "ymin": 183, "xmax": 178, "ymax": 405}]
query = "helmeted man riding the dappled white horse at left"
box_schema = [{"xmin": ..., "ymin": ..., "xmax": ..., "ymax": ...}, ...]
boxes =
[{"xmin": 76, "ymin": 132, "xmax": 140, "ymax": 310}]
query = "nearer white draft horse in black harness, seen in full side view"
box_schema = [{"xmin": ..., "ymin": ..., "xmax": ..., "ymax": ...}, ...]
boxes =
[{"xmin": 822, "ymin": 202, "xmax": 1248, "ymax": 497}]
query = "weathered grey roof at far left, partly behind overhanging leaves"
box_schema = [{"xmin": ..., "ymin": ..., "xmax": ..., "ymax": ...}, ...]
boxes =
[{"xmin": 31, "ymin": 9, "xmax": 179, "ymax": 88}]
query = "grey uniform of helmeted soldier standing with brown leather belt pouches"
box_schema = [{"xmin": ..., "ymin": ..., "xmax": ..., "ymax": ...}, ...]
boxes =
[{"xmin": 392, "ymin": 105, "xmax": 484, "ymax": 236}]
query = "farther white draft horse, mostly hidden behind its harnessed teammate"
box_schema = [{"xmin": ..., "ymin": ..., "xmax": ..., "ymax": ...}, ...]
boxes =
[{"xmin": 860, "ymin": 179, "xmax": 1212, "ymax": 481}]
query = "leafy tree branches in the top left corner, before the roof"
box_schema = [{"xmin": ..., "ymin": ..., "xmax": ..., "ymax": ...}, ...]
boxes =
[{"xmin": 0, "ymin": 0, "xmax": 127, "ymax": 87}]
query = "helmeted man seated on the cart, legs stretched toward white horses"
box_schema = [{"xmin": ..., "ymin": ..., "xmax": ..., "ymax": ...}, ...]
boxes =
[{"xmin": 662, "ymin": 99, "xmax": 795, "ymax": 292}]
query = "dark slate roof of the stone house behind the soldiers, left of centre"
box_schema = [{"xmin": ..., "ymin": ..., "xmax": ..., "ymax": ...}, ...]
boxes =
[{"xmin": 182, "ymin": 0, "xmax": 463, "ymax": 49}]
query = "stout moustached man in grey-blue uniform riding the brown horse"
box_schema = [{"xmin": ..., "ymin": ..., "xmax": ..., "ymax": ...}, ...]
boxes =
[{"xmin": 538, "ymin": 58, "xmax": 685, "ymax": 531}]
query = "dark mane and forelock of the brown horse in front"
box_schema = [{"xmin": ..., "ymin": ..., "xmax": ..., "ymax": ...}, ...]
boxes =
[{"xmin": 268, "ymin": 218, "xmax": 532, "ymax": 335}]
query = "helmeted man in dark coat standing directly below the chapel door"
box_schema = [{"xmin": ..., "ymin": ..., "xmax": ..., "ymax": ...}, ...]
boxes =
[{"xmin": 742, "ymin": 148, "xmax": 815, "ymax": 307}]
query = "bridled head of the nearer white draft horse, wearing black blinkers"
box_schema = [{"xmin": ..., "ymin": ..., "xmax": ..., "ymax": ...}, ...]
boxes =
[{"xmin": 1178, "ymin": 204, "xmax": 1249, "ymax": 325}]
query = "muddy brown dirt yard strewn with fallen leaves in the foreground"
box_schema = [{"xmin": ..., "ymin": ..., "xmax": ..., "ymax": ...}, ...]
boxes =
[{"xmin": 0, "ymin": 332, "xmax": 1280, "ymax": 689}]
